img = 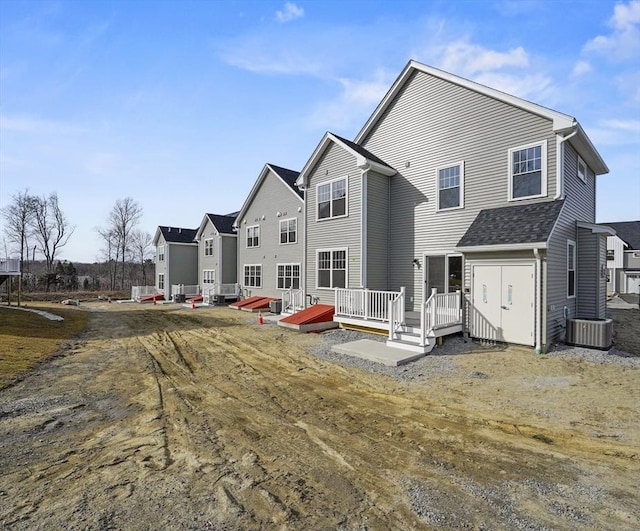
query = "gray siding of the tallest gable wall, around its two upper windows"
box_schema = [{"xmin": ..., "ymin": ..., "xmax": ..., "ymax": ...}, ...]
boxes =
[{"xmin": 362, "ymin": 72, "xmax": 556, "ymax": 309}]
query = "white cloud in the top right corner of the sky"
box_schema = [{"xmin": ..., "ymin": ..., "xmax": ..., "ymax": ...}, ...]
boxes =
[{"xmin": 584, "ymin": 0, "xmax": 640, "ymax": 61}]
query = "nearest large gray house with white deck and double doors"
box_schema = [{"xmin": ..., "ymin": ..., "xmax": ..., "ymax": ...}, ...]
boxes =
[{"xmin": 297, "ymin": 61, "xmax": 613, "ymax": 352}]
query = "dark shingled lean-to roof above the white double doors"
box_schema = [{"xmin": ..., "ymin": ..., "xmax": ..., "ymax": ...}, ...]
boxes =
[{"xmin": 457, "ymin": 201, "xmax": 563, "ymax": 252}]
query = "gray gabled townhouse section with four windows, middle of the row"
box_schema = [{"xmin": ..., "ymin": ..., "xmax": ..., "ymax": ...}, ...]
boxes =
[{"xmin": 235, "ymin": 164, "xmax": 304, "ymax": 311}]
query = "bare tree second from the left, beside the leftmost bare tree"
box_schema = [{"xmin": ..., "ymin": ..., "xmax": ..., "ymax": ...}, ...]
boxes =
[{"xmin": 32, "ymin": 192, "xmax": 75, "ymax": 291}]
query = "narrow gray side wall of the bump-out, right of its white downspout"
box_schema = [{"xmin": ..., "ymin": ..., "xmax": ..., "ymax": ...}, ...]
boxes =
[{"xmin": 366, "ymin": 171, "xmax": 389, "ymax": 290}]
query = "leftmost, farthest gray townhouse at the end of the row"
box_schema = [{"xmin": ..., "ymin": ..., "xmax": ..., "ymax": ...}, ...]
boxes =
[{"xmin": 153, "ymin": 225, "xmax": 198, "ymax": 300}]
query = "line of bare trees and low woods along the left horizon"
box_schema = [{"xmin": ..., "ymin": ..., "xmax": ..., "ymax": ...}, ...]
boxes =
[{"xmin": 0, "ymin": 190, "xmax": 155, "ymax": 300}]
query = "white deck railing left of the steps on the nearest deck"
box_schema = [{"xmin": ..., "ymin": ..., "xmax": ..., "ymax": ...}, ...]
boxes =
[{"xmin": 335, "ymin": 288, "xmax": 404, "ymax": 323}]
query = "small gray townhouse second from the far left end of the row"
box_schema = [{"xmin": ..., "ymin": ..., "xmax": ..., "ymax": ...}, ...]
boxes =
[{"xmin": 195, "ymin": 212, "xmax": 239, "ymax": 303}]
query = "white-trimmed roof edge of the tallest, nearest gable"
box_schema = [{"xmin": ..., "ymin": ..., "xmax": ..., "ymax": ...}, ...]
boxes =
[{"xmin": 355, "ymin": 61, "xmax": 609, "ymax": 175}]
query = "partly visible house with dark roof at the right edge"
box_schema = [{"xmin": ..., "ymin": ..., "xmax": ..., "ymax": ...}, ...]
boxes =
[{"xmin": 602, "ymin": 221, "xmax": 640, "ymax": 293}]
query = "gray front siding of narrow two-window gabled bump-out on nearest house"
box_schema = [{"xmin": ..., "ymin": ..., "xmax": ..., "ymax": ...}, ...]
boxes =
[{"xmin": 305, "ymin": 143, "xmax": 362, "ymax": 304}]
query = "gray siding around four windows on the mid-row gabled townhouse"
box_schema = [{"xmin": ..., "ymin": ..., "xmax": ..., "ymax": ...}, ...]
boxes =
[{"xmin": 236, "ymin": 171, "xmax": 303, "ymax": 297}]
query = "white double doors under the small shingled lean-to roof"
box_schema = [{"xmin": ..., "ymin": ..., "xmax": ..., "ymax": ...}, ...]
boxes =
[{"xmin": 470, "ymin": 264, "xmax": 535, "ymax": 345}]
